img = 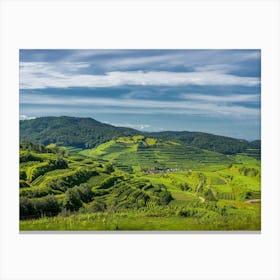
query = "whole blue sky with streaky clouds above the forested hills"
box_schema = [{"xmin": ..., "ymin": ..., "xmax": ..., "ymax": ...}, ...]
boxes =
[{"xmin": 19, "ymin": 49, "xmax": 261, "ymax": 140}]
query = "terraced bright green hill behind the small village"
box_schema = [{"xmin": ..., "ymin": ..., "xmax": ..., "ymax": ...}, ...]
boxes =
[{"xmin": 80, "ymin": 135, "xmax": 236, "ymax": 172}]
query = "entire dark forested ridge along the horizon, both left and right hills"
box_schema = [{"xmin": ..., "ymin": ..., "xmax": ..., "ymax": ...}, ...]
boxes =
[{"xmin": 20, "ymin": 116, "xmax": 261, "ymax": 158}]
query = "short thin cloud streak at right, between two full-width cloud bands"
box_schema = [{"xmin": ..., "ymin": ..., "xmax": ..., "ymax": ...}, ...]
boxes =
[{"xmin": 179, "ymin": 93, "xmax": 260, "ymax": 103}]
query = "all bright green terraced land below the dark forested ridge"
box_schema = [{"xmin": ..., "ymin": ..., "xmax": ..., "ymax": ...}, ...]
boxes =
[{"xmin": 20, "ymin": 135, "xmax": 261, "ymax": 231}]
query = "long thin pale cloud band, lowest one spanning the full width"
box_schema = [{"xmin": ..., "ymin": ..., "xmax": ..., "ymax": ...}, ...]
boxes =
[{"xmin": 20, "ymin": 94, "xmax": 260, "ymax": 116}]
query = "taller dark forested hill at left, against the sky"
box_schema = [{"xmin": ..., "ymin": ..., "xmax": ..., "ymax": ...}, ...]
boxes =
[{"xmin": 20, "ymin": 116, "xmax": 139, "ymax": 149}]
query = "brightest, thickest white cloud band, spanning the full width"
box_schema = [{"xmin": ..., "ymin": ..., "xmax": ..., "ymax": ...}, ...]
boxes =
[{"xmin": 20, "ymin": 62, "xmax": 260, "ymax": 89}]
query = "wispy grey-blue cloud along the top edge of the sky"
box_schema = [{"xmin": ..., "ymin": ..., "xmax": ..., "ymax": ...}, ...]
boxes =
[{"xmin": 58, "ymin": 49, "xmax": 260, "ymax": 70}]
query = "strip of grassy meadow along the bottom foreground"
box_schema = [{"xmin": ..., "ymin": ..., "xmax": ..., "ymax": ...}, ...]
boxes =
[{"xmin": 20, "ymin": 204, "xmax": 261, "ymax": 231}]
